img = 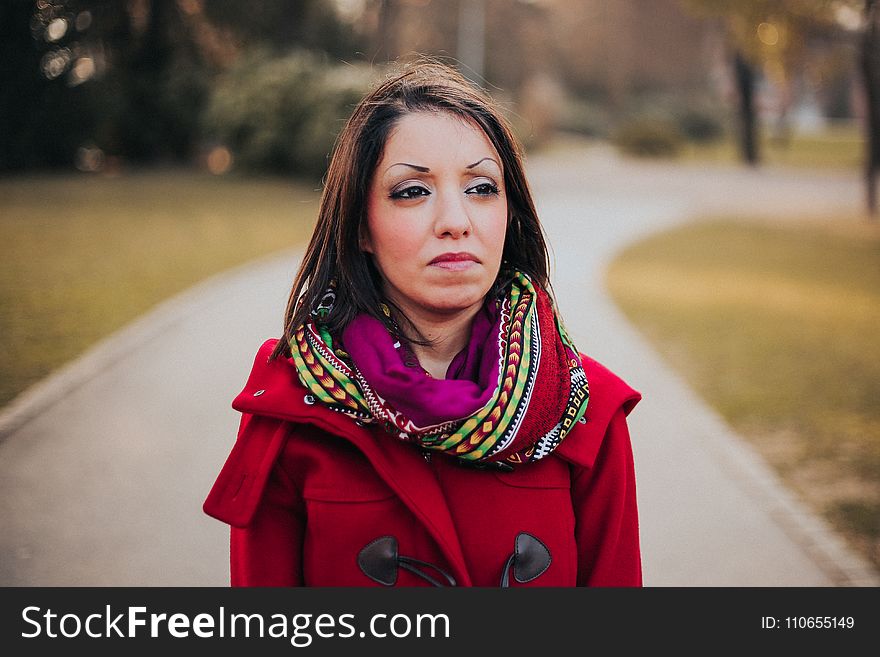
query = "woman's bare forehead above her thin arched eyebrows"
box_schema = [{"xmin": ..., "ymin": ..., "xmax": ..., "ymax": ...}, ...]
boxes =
[{"xmin": 382, "ymin": 112, "xmax": 498, "ymax": 166}]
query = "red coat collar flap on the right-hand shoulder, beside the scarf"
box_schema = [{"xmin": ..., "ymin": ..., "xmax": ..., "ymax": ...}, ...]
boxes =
[{"xmin": 555, "ymin": 354, "xmax": 642, "ymax": 468}]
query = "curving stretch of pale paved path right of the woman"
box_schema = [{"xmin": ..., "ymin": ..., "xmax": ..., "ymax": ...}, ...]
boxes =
[{"xmin": 530, "ymin": 149, "xmax": 880, "ymax": 586}]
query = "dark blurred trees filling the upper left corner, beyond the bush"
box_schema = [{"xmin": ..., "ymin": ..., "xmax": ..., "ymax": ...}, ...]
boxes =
[{"xmin": 0, "ymin": 0, "xmax": 359, "ymax": 170}]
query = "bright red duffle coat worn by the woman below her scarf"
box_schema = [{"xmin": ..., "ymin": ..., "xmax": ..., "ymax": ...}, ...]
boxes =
[{"xmin": 204, "ymin": 340, "xmax": 642, "ymax": 586}]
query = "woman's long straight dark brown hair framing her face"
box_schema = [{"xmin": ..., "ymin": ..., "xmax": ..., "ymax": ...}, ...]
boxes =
[{"xmin": 271, "ymin": 58, "xmax": 550, "ymax": 358}]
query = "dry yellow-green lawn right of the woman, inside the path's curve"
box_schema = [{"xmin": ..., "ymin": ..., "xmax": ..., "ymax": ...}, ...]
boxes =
[{"xmin": 608, "ymin": 217, "xmax": 880, "ymax": 565}]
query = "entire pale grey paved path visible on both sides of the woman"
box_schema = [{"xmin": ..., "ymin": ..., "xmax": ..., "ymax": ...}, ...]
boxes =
[{"xmin": 0, "ymin": 145, "xmax": 880, "ymax": 586}]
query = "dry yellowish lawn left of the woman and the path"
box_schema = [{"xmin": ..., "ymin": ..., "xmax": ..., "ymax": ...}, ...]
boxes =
[{"xmin": 0, "ymin": 171, "xmax": 318, "ymax": 405}]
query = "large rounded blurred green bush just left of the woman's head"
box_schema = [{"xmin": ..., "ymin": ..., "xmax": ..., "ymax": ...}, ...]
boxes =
[{"xmin": 203, "ymin": 51, "xmax": 373, "ymax": 178}]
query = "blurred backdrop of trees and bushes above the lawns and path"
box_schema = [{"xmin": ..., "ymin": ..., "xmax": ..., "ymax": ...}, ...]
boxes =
[{"xmin": 0, "ymin": 0, "xmax": 877, "ymax": 176}]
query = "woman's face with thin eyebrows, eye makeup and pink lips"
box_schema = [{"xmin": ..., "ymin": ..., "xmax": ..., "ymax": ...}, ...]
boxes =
[{"xmin": 361, "ymin": 112, "xmax": 507, "ymax": 319}]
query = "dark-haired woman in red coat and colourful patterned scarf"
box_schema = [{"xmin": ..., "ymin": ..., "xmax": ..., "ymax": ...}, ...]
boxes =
[{"xmin": 204, "ymin": 62, "xmax": 642, "ymax": 586}]
